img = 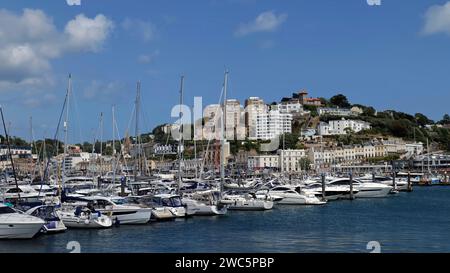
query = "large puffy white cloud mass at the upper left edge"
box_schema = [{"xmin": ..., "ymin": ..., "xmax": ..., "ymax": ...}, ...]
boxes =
[{"xmin": 0, "ymin": 9, "xmax": 113, "ymax": 92}]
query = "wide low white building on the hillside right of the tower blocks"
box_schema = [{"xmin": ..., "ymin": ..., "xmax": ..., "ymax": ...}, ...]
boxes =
[{"xmin": 317, "ymin": 119, "xmax": 371, "ymax": 136}]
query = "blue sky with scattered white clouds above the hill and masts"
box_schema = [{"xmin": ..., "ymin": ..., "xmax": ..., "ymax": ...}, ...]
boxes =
[{"xmin": 0, "ymin": 0, "xmax": 450, "ymax": 142}]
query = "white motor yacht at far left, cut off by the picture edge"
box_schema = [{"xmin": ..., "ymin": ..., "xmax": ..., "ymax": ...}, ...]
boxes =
[{"xmin": 0, "ymin": 204, "xmax": 45, "ymax": 239}]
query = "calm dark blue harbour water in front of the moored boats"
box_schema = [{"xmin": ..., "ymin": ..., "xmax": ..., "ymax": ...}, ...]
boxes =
[{"xmin": 0, "ymin": 187, "xmax": 450, "ymax": 253}]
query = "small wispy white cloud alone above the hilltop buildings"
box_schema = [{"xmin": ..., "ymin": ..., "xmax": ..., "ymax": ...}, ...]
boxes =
[{"xmin": 235, "ymin": 11, "xmax": 288, "ymax": 36}]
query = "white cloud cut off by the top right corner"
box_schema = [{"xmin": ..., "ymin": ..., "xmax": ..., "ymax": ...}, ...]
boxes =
[{"xmin": 422, "ymin": 1, "xmax": 450, "ymax": 35}]
